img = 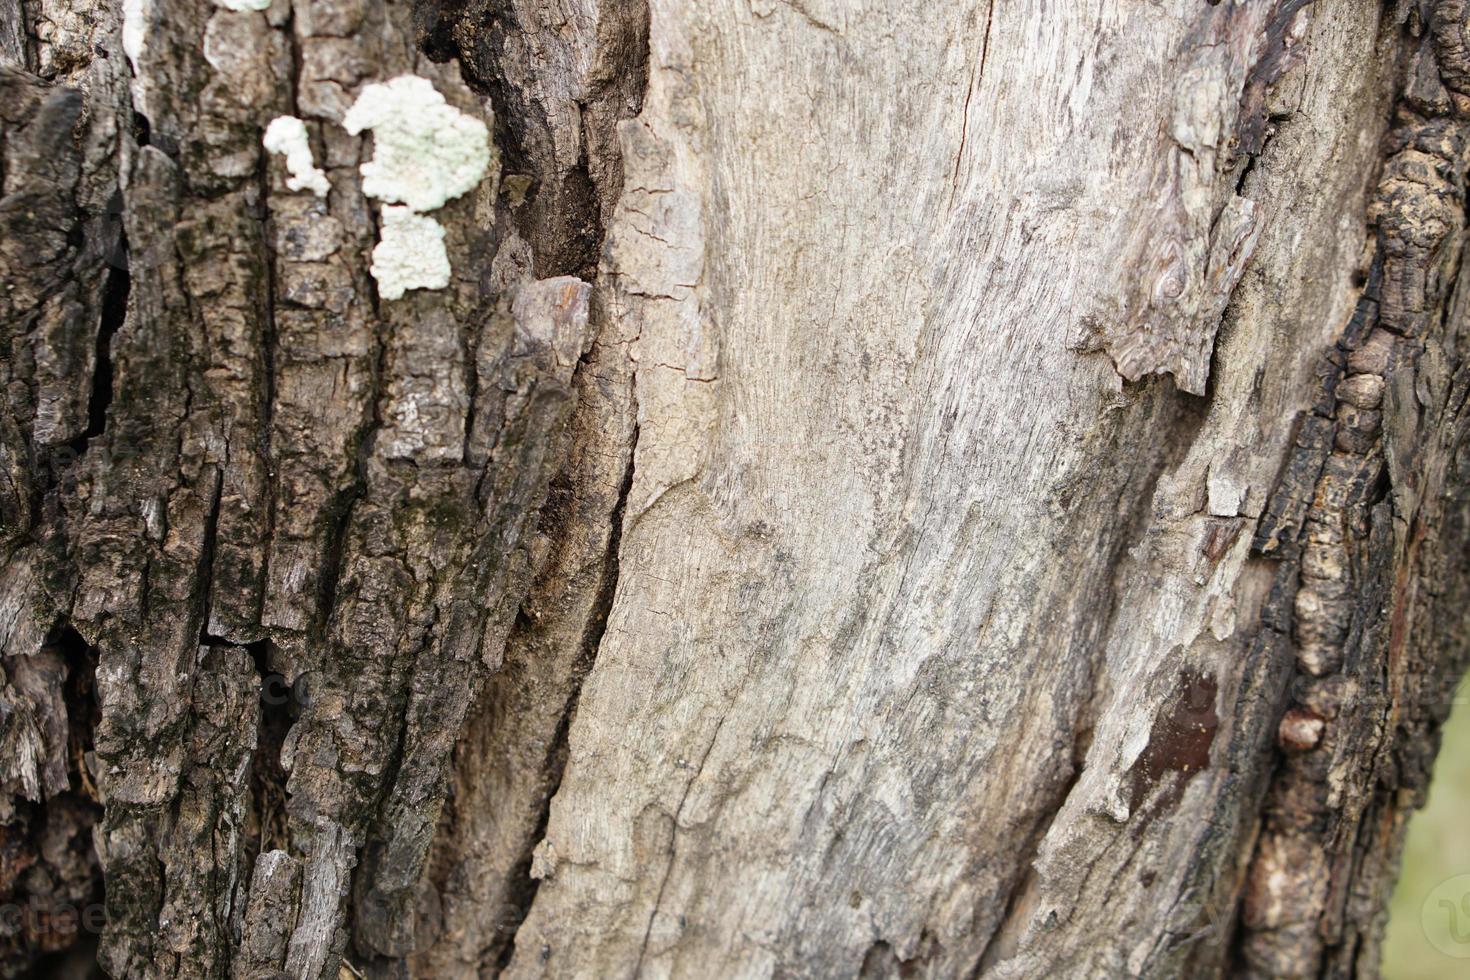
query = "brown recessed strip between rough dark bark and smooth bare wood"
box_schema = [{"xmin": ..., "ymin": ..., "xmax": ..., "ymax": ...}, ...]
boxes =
[{"xmin": 416, "ymin": 3, "xmax": 647, "ymax": 974}]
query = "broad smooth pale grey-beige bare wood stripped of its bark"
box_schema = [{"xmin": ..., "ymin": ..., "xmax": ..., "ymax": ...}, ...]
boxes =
[{"xmin": 510, "ymin": 3, "xmax": 1463, "ymax": 977}]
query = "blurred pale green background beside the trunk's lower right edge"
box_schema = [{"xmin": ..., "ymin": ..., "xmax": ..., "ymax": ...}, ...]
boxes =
[{"xmin": 1383, "ymin": 683, "xmax": 1470, "ymax": 980}]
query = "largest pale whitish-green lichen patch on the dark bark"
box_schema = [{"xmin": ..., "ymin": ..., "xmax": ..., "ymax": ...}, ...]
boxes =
[{"xmin": 343, "ymin": 75, "xmax": 490, "ymax": 212}]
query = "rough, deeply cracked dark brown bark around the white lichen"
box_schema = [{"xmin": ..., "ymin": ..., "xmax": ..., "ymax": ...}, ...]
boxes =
[{"xmin": 3, "ymin": 3, "xmax": 641, "ymax": 976}]
